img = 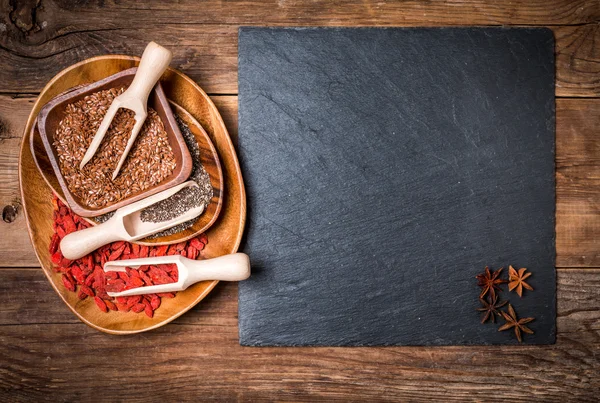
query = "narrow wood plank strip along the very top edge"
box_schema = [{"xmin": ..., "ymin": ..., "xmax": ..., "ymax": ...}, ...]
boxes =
[{"xmin": 17, "ymin": 0, "xmax": 600, "ymax": 26}]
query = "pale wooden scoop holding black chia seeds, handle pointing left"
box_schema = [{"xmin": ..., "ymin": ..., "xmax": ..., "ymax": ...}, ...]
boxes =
[{"xmin": 60, "ymin": 181, "xmax": 204, "ymax": 260}]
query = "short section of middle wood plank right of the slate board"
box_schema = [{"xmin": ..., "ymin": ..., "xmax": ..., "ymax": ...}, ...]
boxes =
[{"xmin": 556, "ymin": 99, "xmax": 600, "ymax": 267}]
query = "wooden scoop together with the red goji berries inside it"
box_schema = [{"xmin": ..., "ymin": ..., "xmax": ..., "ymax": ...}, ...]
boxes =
[{"xmin": 104, "ymin": 253, "xmax": 250, "ymax": 297}]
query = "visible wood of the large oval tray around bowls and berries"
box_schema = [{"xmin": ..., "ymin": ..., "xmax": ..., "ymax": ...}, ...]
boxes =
[{"xmin": 19, "ymin": 56, "xmax": 246, "ymax": 334}]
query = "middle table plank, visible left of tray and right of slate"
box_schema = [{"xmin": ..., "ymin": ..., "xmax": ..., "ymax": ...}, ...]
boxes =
[{"xmin": 0, "ymin": 95, "xmax": 600, "ymax": 267}]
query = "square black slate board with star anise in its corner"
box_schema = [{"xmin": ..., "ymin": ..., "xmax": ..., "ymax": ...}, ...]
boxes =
[{"xmin": 239, "ymin": 28, "xmax": 555, "ymax": 346}]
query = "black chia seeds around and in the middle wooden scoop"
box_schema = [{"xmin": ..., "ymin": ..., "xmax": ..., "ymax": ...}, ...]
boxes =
[{"xmin": 96, "ymin": 115, "xmax": 213, "ymax": 239}]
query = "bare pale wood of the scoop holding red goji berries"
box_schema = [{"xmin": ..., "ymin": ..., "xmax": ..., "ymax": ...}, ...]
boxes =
[{"xmin": 104, "ymin": 253, "xmax": 250, "ymax": 297}]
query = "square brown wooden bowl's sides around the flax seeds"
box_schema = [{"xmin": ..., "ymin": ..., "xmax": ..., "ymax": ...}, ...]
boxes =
[{"xmin": 37, "ymin": 67, "xmax": 193, "ymax": 217}]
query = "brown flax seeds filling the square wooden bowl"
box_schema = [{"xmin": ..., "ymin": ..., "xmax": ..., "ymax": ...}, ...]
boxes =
[{"xmin": 53, "ymin": 88, "xmax": 176, "ymax": 208}]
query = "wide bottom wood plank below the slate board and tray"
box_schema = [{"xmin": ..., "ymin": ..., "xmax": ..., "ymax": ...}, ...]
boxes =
[{"xmin": 0, "ymin": 269, "xmax": 600, "ymax": 401}]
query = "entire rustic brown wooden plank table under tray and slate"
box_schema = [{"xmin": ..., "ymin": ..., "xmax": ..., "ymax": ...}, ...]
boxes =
[{"xmin": 0, "ymin": 0, "xmax": 600, "ymax": 401}]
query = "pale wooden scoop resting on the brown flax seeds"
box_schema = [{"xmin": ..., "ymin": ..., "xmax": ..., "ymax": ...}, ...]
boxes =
[{"xmin": 79, "ymin": 42, "xmax": 173, "ymax": 180}]
